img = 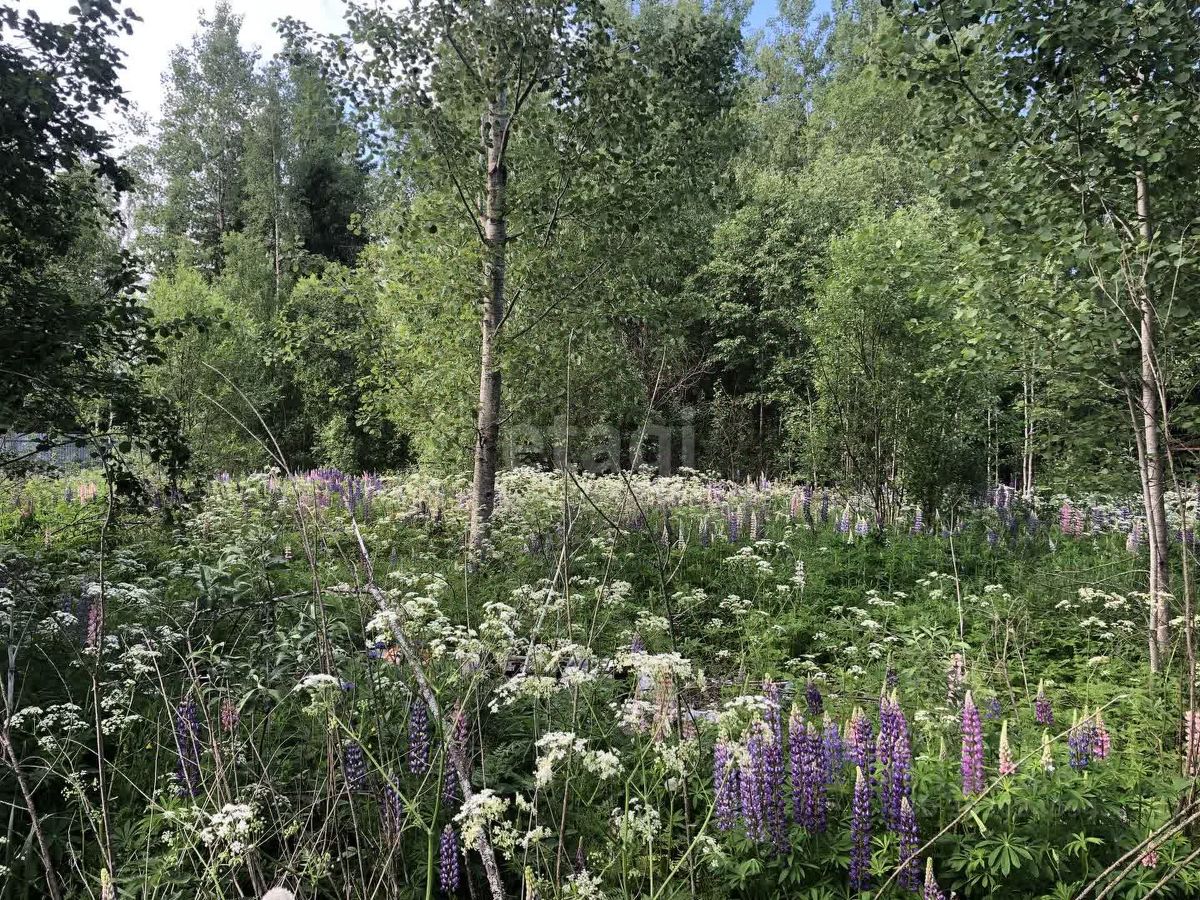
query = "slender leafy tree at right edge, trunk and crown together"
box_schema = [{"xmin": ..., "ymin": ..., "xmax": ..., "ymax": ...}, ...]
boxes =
[{"xmin": 886, "ymin": 0, "xmax": 1200, "ymax": 671}]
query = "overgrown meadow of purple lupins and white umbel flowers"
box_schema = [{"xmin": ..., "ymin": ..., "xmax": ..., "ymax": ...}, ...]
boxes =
[{"xmin": 0, "ymin": 470, "xmax": 1200, "ymax": 900}]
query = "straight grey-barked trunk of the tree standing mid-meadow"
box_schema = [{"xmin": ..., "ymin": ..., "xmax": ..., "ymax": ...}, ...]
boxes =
[{"xmin": 468, "ymin": 89, "xmax": 509, "ymax": 552}]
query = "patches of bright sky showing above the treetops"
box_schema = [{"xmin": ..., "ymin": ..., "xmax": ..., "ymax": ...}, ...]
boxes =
[{"xmin": 28, "ymin": 0, "xmax": 775, "ymax": 119}]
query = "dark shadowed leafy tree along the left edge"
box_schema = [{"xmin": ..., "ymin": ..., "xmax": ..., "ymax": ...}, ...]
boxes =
[{"xmin": 0, "ymin": 0, "xmax": 186, "ymax": 485}]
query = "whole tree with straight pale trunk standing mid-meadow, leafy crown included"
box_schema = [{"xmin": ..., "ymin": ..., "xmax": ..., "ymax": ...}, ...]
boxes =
[{"xmin": 286, "ymin": 0, "xmax": 736, "ymax": 551}]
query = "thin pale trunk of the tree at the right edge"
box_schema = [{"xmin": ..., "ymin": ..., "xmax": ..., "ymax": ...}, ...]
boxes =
[{"xmin": 1135, "ymin": 169, "xmax": 1170, "ymax": 671}]
